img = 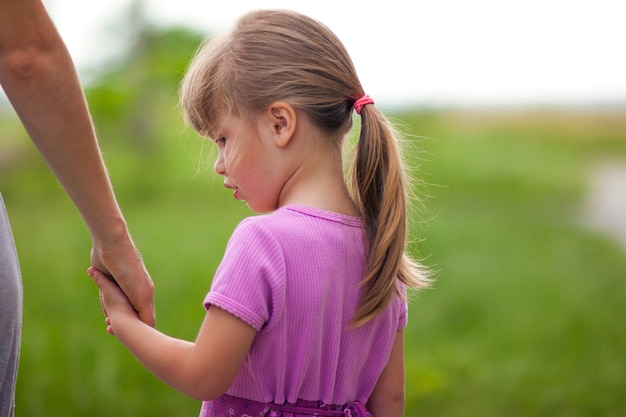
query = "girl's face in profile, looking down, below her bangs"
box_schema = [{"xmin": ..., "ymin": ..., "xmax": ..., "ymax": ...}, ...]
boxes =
[{"xmin": 214, "ymin": 115, "xmax": 287, "ymax": 213}]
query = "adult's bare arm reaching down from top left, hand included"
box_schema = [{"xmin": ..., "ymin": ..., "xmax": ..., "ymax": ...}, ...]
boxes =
[{"xmin": 0, "ymin": 0, "xmax": 155, "ymax": 325}]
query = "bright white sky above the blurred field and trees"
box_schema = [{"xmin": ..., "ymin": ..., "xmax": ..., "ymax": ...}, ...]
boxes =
[{"xmin": 22, "ymin": 0, "xmax": 626, "ymax": 106}]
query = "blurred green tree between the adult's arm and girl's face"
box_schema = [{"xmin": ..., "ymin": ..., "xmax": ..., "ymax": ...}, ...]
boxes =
[{"xmin": 70, "ymin": 1, "xmax": 211, "ymax": 199}]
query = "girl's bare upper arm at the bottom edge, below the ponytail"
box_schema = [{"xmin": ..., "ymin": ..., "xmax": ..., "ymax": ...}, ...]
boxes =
[{"xmin": 367, "ymin": 330, "xmax": 405, "ymax": 417}]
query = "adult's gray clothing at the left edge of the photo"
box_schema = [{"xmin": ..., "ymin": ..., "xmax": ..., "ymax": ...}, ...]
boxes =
[{"xmin": 0, "ymin": 194, "xmax": 22, "ymax": 417}]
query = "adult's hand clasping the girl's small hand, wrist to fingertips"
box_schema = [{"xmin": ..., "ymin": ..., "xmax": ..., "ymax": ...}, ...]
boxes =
[{"xmin": 91, "ymin": 234, "xmax": 156, "ymax": 326}]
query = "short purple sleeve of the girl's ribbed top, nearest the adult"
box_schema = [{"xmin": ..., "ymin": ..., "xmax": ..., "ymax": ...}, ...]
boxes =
[{"xmin": 204, "ymin": 216, "xmax": 285, "ymax": 331}]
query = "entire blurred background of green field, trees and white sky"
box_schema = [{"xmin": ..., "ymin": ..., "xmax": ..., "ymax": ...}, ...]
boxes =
[{"xmin": 0, "ymin": 0, "xmax": 626, "ymax": 417}]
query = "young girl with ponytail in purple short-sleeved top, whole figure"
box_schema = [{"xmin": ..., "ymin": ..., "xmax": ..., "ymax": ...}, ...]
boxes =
[{"xmin": 89, "ymin": 11, "xmax": 427, "ymax": 417}]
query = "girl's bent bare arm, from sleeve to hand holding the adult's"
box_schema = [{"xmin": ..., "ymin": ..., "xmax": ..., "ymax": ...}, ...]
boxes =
[{"xmin": 88, "ymin": 267, "xmax": 256, "ymax": 400}]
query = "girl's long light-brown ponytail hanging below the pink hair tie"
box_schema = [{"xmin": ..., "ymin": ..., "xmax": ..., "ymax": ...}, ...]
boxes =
[{"xmin": 352, "ymin": 102, "xmax": 429, "ymax": 327}]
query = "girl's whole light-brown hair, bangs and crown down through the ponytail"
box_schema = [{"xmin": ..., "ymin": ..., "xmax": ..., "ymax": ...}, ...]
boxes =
[{"xmin": 181, "ymin": 10, "xmax": 428, "ymax": 326}]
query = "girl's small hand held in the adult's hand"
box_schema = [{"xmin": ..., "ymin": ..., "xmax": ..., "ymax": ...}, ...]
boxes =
[{"xmin": 87, "ymin": 266, "xmax": 138, "ymax": 335}]
